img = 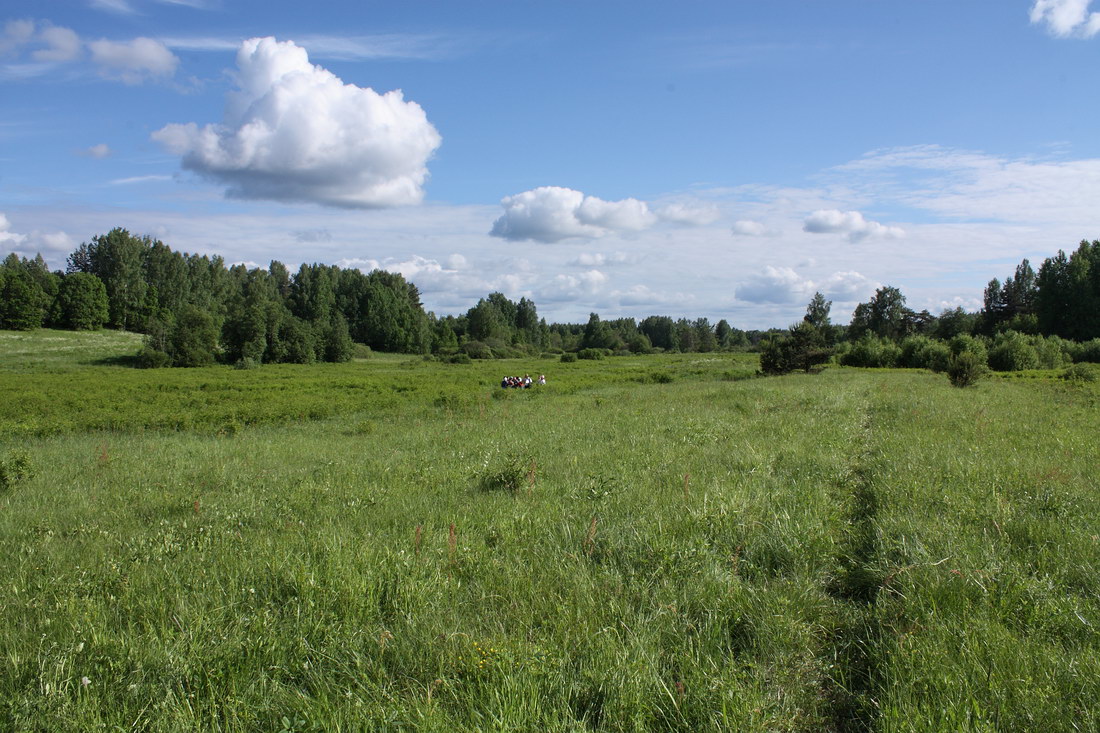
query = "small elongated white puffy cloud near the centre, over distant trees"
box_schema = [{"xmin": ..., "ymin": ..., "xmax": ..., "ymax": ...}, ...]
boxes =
[{"xmin": 490, "ymin": 186, "xmax": 657, "ymax": 243}]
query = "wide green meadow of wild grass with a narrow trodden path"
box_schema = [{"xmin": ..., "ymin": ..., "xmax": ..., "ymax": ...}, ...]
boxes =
[{"xmin": 0, "ymin": 331, "xmax": 1100, "ymax": 731}]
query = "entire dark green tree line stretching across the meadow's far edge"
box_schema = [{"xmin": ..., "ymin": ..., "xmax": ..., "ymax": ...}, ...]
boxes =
[{"xmin": 0, "ymin": 229, "xmax": 1100, "ymax": 365}]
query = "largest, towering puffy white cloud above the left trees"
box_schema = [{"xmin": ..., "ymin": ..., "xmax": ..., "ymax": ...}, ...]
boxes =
[{"xmin": 153, "ymin": 37, "xmax": 441, "ymax": 208}]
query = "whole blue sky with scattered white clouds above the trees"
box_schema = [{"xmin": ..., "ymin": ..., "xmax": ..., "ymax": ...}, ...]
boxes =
[{"xmin": 0, "ymin": 0, "xmax": 1100, "ymax": 329}]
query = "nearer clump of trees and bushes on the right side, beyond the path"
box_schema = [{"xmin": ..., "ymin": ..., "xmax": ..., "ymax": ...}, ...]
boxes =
[{"xmin": 761, "ymin": 241, "xmax": 1100, "ymax": 373}]
